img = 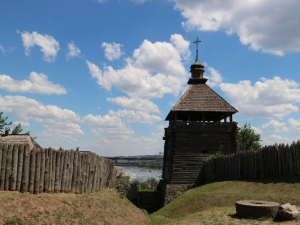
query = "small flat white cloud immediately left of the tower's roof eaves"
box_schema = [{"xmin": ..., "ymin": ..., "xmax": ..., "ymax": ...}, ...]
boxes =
[{"xmin": 109, "ymin": 109, "xmax": 161, "ymax": 124}]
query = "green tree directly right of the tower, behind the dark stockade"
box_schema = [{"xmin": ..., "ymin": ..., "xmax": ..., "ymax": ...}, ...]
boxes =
[{"xmin": 238, "ymin": 123, "xmax": 261, "ymax": 151}]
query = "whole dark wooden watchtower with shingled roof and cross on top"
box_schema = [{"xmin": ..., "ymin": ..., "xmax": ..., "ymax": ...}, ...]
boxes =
[{"xmin": 163, "ymin": 38, "xmax": 238, "ymax": 186}]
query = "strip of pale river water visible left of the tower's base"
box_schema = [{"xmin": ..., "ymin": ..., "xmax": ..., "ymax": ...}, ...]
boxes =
[{"xmin": 118, "ymin": 166, "xmax": 162, "ymax": 182}]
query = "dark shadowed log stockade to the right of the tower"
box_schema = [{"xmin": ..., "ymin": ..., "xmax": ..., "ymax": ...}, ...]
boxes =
[{"xmin": 203, "ymin": 141, "xmax": 300, "ymax": 183}]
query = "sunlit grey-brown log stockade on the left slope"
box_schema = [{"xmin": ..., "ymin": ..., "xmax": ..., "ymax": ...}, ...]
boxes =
[{"xmin": 0, "ymin": 143, "xmax": 116, "ymax": 194}]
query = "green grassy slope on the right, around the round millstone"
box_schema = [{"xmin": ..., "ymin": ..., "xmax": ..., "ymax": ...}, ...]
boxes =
[{"xmin": 151, "ymin": 177, "xmax": 300, "ymax": 225}]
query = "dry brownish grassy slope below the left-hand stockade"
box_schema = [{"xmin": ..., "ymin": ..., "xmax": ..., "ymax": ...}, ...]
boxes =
[{"xmin": 0, "ymin": 189, "xmax": 150, "ymax": 225}]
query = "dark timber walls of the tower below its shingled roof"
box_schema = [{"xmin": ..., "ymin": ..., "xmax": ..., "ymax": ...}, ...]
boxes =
[{"xmin": 163, "ymin": 121, "xmax": 238, "ymax": 184}]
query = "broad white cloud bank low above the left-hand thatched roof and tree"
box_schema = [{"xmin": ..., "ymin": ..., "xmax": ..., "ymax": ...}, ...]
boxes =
[{"xmin": 0, "ymin": 95, "xmax": 84, "ymax": 141}]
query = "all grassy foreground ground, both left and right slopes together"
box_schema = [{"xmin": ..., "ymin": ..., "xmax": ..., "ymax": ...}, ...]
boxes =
[{"xmin": 0, "ymin": 177, "xmax": 300, "ymax": 225}]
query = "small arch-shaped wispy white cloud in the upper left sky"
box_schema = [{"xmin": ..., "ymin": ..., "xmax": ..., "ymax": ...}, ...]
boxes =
[{"xmin": 21, "ymin": 31, "xmax": 59, "ymax": 62}]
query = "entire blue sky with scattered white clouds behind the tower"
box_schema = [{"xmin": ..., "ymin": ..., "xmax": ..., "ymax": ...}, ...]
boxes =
[{"xmin": 0, "ymin": 0, "xmax": 300, "ymax": 156}]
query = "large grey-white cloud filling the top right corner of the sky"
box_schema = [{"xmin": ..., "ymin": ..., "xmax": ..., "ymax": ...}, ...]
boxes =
[{"xmin": 172, "ymin": 0, "xmax": 300, "ymax": 56}]
